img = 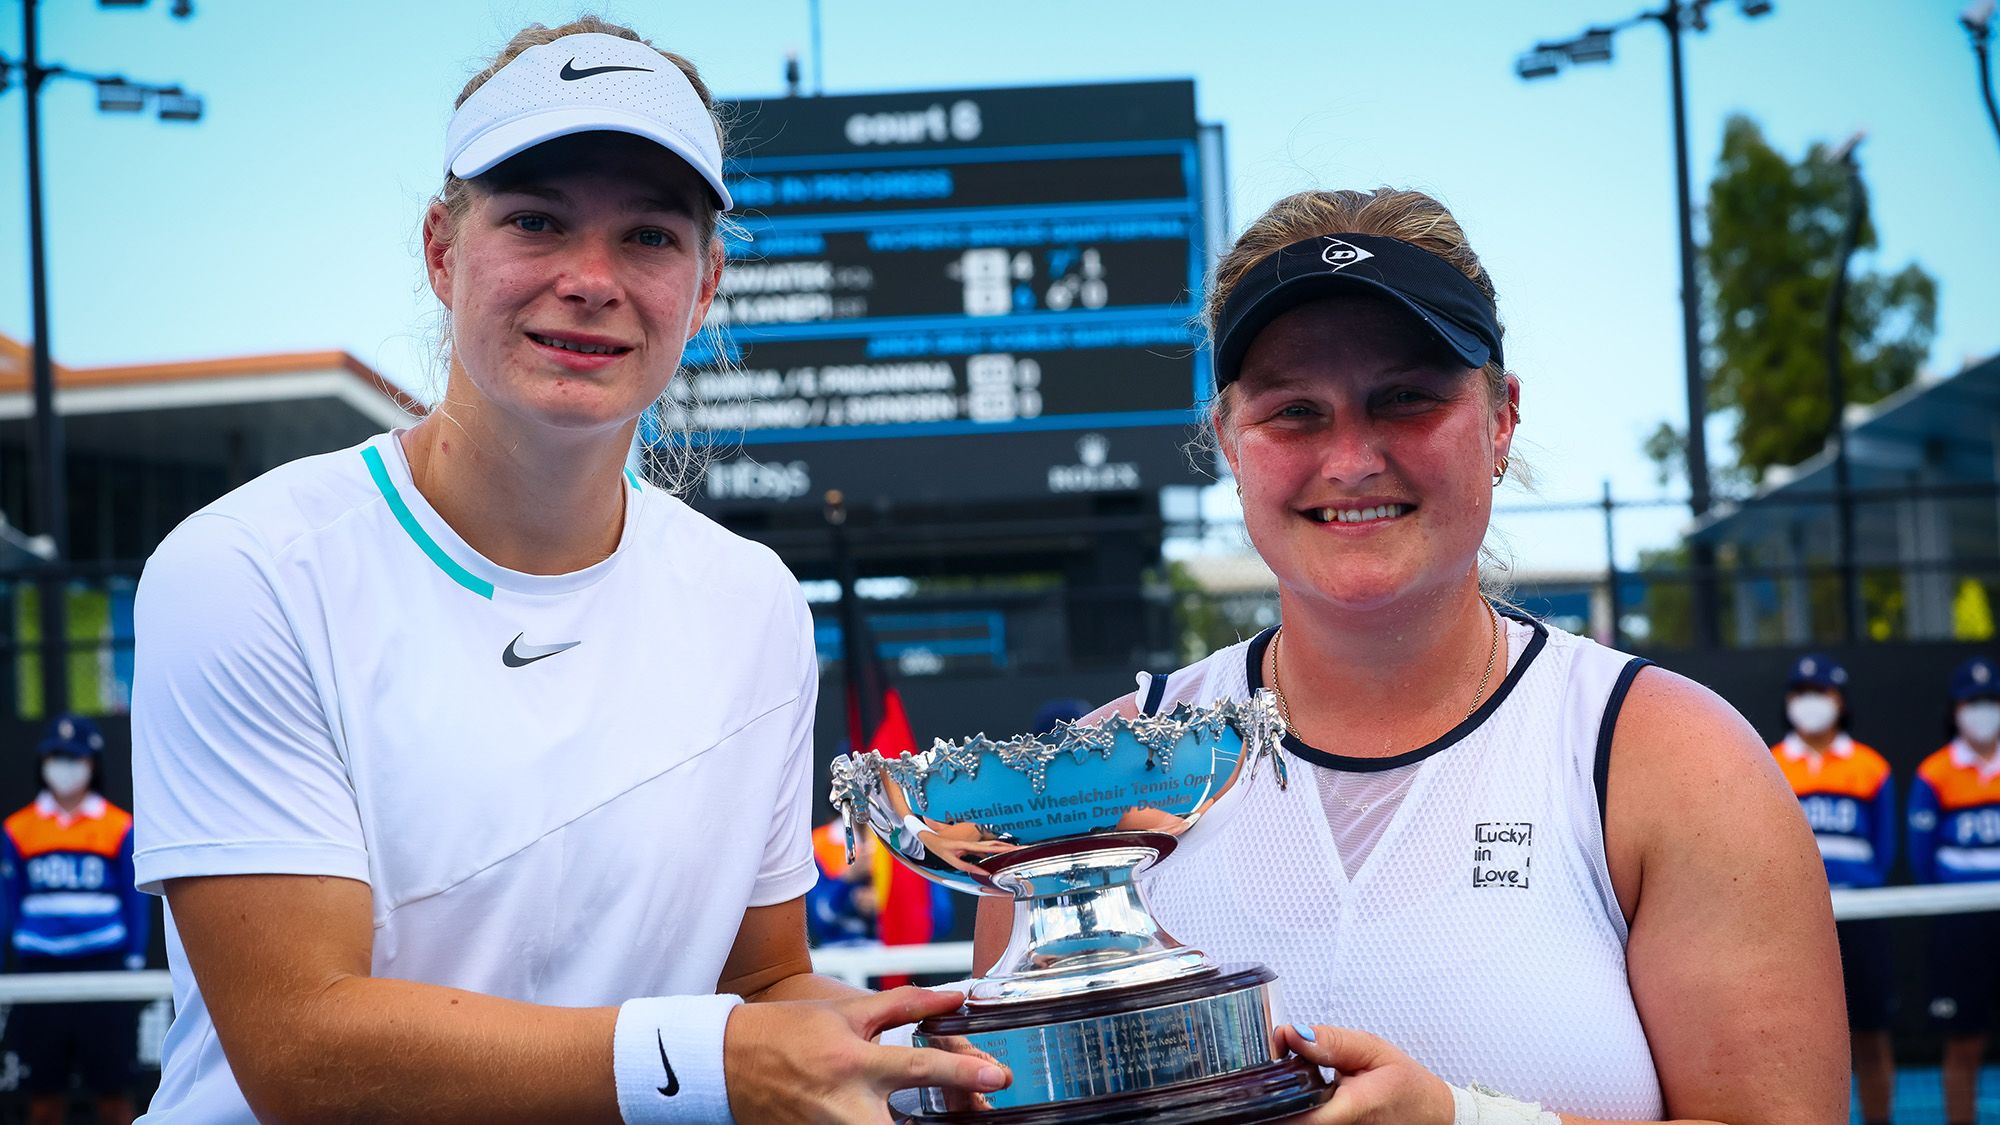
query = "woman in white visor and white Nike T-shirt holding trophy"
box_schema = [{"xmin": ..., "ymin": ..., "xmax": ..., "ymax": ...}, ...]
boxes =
[{"xmin": 134, "ymin": 20, "xmax": 1006, "ymax": 1125}]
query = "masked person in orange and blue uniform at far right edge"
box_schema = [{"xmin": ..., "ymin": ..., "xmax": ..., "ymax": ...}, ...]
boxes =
[{"xmin": 1910, "ymin": 657, "xmax": 2000, "ymax": 1125}]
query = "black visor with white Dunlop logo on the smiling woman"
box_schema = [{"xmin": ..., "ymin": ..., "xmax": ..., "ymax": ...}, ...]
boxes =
[{"xmin": 1214, "ymin": 234, "xmax": 1502, "ymax": 390}]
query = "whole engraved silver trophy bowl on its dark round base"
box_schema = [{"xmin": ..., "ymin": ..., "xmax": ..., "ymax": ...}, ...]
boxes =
[{"xmin": 832, "ymin": 693, "xmax": 1332, "ymax": 1125}]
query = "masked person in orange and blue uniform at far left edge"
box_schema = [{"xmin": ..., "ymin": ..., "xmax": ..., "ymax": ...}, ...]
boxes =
[{"xmin": 0, "ymin": 715, "xmax": 150, "ymax": 1125}]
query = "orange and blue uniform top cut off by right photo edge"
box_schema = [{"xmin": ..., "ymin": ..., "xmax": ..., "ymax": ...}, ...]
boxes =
[{"xmin": 1910, "ymin": 739, "xmax": 2000, "ymax": 883}]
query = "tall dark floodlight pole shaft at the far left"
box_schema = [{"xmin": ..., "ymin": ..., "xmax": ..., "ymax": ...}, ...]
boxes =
[{"xmin": 20, "ymin": 0, "xmax": 70, "ymax": 719}]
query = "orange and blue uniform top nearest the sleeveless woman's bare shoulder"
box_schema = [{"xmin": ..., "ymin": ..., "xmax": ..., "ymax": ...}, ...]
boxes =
[{"xmin": 1770, "ymin": 735, "xmax": 1896, "ymax": 887}]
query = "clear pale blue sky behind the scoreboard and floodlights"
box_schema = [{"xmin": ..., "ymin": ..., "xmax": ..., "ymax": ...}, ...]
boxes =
[{"xmin": 0, "ymin": 0, "xmax": 2000, "ymax": 569}]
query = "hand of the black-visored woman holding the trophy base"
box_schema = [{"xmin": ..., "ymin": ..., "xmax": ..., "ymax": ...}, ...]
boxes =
[{"xmin": 1272, "ymin": 1023, "xmax": 1454, "ymax": 1125}]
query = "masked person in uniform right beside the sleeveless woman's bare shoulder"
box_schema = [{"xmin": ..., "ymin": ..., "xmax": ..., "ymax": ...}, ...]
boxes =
[{"xmin": 1772, "ymin": 655, "xmax": 1896, "ymax": 1125}]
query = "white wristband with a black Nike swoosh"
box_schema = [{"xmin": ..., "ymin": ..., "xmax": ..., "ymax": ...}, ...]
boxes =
[{"xmin": 612, "ymin": 995, "xmax": 744, "ymax": 1125}]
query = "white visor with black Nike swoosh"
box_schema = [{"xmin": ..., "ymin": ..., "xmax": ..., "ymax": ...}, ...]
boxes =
[{"xmin": 444, "ymin": 32, "xmax": 734, "ymax": 210}]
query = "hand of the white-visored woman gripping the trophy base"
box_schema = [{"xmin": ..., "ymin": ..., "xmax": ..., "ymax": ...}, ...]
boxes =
[{"xmin": 722, "ymin": 976, "xmax": 1012, "ymax": 1125}]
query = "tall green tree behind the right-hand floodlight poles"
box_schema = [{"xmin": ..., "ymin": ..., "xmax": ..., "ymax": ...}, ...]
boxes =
[{"xmin": 1644, "ymin": 116, "xmax": 1938, "ymax": 484}]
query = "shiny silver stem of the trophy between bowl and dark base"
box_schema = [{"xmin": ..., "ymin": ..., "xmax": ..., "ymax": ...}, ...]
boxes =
[{"xmin": 968, "ymin": 833, "xmax": 1214, "ymax": 1005}]
